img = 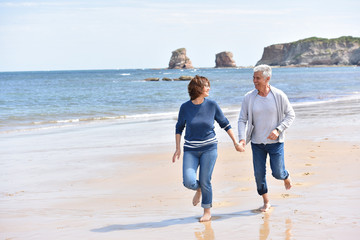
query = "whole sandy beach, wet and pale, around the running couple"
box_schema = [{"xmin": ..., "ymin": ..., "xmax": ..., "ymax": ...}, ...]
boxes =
[{"xmin": 0, "ymin": 97, "xmax": 360, "ymax": 240}]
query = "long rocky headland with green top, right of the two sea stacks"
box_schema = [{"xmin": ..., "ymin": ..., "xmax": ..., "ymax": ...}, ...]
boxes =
[{"xmin": 256, "ymin": 36, "xmax": 360, "ymax": 66}]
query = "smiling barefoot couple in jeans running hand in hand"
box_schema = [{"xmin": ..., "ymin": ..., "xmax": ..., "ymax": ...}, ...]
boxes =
[{"xmin": 172, "ymin": 65, "xmax": 295, "ymax": 222}]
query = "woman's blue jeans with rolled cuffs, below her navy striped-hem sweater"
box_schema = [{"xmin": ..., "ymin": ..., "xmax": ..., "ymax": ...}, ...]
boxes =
[{"xmin": 183, "ymin": 148, "xmax": 217, "ymax": 208}]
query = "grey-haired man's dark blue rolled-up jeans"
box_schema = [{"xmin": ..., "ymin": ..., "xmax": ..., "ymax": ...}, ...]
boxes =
[{"xmin": 251, "ymin": 143, "xmax": 289, "ymax": 195}]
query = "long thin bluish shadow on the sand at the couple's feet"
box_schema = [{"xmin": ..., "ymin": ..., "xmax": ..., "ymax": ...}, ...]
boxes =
[{"xmin": 91, "ymin": 210, "xmax": 260, "ymax": 233}]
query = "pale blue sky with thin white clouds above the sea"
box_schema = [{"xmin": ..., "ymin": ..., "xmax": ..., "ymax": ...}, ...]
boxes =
[{"xmin": 0, "ymin": 0, "xmax": 360, "ymax": 72}]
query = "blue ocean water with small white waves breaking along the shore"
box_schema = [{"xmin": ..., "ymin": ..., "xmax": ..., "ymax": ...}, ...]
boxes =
[{"xmin": 0, "ymin": 67, "xmax": 360, "ymax": 134}]
